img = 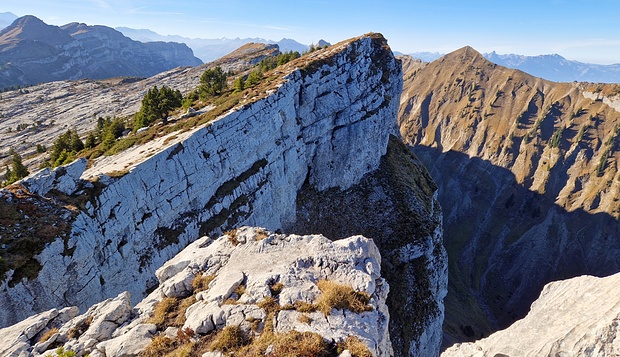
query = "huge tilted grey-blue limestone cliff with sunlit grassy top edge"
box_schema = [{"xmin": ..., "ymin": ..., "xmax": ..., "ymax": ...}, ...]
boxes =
[{"xmin": 0, "ymin": 34, "xmax": 446, "ymax": 356}]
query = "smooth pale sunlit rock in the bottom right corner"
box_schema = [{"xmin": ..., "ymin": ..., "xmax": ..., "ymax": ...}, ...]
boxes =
[{"xmin": 442, "ymin": 274, "xmax": 620, "ymax": 357}]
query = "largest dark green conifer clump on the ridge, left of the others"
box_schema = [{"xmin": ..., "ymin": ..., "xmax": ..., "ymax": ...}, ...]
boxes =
[{"xmin": 134, "ymin": 84, "xmax": 183, "ymax": 129}]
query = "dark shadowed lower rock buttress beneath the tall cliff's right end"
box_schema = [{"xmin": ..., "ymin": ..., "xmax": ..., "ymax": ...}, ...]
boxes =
[{"xmin": 290, "ymin": 137, "xmax": 448, "ymax": 356}]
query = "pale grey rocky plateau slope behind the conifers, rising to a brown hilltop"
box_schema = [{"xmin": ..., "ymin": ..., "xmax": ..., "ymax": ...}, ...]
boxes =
[{"xmin": 0, "ymin": 44, "xmax": 279, "ymax": 172}]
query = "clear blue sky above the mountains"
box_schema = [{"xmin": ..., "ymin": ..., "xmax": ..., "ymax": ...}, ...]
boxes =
[{"xmin": 0, "ymin": 0, "xmax": 620, "ymax": 64}]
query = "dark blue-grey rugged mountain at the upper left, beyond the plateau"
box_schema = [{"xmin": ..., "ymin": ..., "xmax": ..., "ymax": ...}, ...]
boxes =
[{"xmin": 0, "ymin": 13, "xmax": 202, "ymax": 89}]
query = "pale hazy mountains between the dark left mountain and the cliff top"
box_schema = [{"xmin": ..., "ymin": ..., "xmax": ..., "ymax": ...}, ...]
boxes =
[{"xmin": 116, "ymin": 27, "xmax": 312, "ymax": 62}]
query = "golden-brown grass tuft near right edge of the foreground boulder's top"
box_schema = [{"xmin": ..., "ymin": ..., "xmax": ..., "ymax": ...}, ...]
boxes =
[{"xmin": 316, "ymin": 280, "xmax": 372, "ymax": 316}]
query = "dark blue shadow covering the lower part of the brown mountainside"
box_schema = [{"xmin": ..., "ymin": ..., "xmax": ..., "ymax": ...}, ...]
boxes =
[{"xmin": 412, "ymin": 146, "xmax": 620, "ymax": 347}]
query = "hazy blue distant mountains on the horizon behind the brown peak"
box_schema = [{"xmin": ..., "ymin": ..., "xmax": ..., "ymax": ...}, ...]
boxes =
[{"xmin": 409, "ymin": 51, "xmax": 620, "ymax": 83}]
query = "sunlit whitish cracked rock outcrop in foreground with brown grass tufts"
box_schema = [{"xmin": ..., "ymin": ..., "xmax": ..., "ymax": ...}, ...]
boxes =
[{"xmin": 0, "ymin": 227, "xmax": 393, "ymax": 356}]
